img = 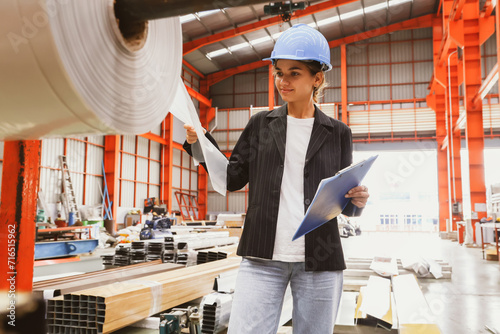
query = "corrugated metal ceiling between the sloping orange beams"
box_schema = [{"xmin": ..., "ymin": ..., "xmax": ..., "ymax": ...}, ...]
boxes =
[{"xmin": 181, "ymin": 0, "xmax": 439, "ymax": 74}]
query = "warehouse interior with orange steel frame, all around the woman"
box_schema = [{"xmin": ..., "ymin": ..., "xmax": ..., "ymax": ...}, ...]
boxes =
[{"xmin": 0, "ymin": 0, "xmax": 500, "ymax": 334}]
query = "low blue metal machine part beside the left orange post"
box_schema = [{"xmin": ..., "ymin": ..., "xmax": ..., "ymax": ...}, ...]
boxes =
[{"xmin": 35, "ymin": 239, "xmax": 99, "ymax": 260}]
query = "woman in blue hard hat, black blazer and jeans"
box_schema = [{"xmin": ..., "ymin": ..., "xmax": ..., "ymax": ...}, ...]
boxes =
[{"xmin": 184, "ymin": 24, "xmax": 369, "ymax": 334}]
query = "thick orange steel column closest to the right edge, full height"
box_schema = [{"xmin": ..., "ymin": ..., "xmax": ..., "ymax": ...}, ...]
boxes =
[{"xmin": 463, "ymin": 0, "xmax": 486, "ymax": 234}]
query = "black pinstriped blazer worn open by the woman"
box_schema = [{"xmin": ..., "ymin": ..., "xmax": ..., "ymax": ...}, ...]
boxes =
[{"xmin": 184, "ymin": 104, "xmax": 361, "ymax": 271}]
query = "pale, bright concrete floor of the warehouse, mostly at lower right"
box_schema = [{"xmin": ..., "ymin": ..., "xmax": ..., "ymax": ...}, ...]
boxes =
[{"xmin": 69, "ymin": 232, "xmax": 500, "ymax": 334}]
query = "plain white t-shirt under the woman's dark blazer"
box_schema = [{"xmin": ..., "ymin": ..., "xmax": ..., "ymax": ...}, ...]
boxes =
[{"xmin": 273, "ymin": 116, "xmax": 314, "ymax": 262}]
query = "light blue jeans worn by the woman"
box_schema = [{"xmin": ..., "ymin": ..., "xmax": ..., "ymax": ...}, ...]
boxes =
[{"xmin": 228, "ymin": 258, "xmax": 343, "ymax": 334}]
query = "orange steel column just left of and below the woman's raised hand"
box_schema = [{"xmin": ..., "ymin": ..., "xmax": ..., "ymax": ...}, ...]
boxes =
[{"xmin": 160, "ymin": 113, "xmax": 174, "ymax": 212}]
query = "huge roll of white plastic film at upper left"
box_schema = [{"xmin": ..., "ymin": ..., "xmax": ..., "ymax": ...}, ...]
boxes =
[{"xmin": 0, "ymin": 0, "xmax": 182, "ymax": 140}]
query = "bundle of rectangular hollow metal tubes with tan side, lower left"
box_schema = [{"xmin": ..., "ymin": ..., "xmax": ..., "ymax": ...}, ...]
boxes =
[{"xmin": 47, "ymin": 257, "xmax": 240, "ymax": 334}]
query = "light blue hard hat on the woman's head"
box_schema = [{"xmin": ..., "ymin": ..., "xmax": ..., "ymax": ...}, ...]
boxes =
[{"xmin": 264, "ymin": 23, "xmax": 332, "ymax": 72}]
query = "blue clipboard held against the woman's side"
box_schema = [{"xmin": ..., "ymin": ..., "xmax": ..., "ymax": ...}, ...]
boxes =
[{"xmin": 292, "ymin": 155, "xmax": 378, "ymax": 241}]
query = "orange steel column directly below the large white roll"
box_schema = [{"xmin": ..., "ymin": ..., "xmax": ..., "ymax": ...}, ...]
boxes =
[{"xmin": 104, "ymin": 135, "xmax": 121, "ymax": 227}]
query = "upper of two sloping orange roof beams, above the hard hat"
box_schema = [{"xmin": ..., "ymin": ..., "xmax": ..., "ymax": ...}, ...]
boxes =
[{"xmin": 183, "ymin": 0, "xmax": 357, "ymax": 55}]
